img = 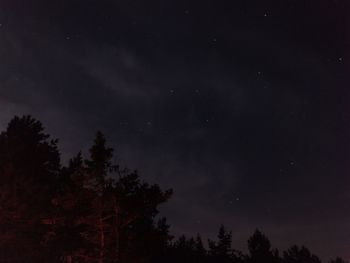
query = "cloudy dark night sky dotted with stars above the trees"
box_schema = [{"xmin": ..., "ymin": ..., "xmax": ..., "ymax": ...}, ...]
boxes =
[{"xmin": 0, "ymin": 0, "xmax": 350, "ymax": 259}]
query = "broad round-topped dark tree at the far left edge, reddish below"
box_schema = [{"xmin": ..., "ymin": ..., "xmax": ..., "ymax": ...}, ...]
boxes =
[{"xmin": 0, "ymin": 116, "xmax": 60, "ymax": 262}]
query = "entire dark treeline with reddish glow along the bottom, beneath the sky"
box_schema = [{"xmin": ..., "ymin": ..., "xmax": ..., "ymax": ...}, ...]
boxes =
[{"xmin": 0, "ymin": 116, "xmax": 345, "ymax": 263}]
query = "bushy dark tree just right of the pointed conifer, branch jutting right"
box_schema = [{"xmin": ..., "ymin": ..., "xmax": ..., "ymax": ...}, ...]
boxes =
[{"xmin": 111, "ymin": 170, "xmax": 172, "ymax": 262}]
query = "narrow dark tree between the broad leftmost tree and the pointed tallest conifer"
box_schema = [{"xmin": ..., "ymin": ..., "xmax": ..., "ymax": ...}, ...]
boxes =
[{"xmin": 49, "ymin": 153, "xmax": 95, "ymax": 262}]
